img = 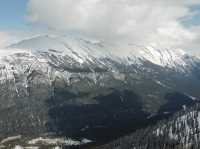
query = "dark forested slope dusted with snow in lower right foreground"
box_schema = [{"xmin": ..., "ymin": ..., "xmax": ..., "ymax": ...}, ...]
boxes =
[{"xmin": 99, "ymin": 104, "xmax": 200, "ymax": 149}]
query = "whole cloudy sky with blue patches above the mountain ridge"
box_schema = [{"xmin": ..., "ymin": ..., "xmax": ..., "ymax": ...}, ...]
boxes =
[{"xmin": 0, "ymin": 0, "xmax": 200, "ymax": 52}]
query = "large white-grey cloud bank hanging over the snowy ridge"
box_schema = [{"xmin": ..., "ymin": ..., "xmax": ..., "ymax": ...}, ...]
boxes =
[{"xmin": 28, "ymin": 0, "xmax": 200, "ymax": 50}]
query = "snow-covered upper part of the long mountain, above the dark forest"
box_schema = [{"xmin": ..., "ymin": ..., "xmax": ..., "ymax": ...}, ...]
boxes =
[{"xmin": 0, "ymin": 36, "xmax": 196, "ymax": 94}]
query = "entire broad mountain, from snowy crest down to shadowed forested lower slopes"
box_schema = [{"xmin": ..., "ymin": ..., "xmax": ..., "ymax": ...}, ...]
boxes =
[{"xmin": 0, "ymin": 35, "xmax": 200, "ymax": 147}]
